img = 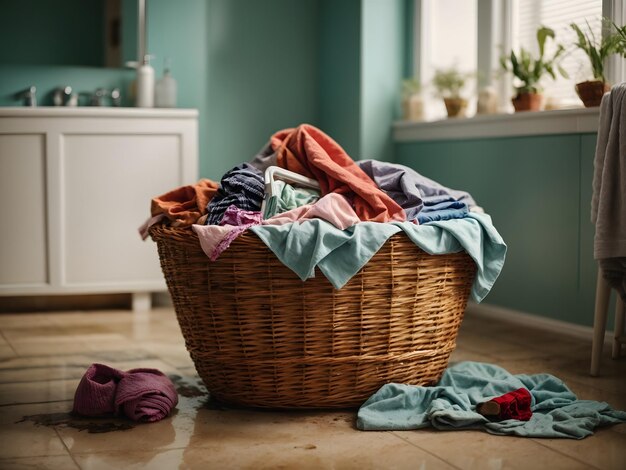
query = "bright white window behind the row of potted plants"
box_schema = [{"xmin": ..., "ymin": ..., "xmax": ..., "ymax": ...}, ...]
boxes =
[{"xmin": 414, "ymin": 0, "xmax": 626, "ymax": 120}]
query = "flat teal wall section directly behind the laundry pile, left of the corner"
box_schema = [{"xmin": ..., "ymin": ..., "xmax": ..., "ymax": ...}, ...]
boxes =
[{"xmin": 207, "ymin": 0, "xmax": 318, "ymax": 179}]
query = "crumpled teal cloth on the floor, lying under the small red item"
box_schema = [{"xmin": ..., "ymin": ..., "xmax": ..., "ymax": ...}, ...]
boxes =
[{"xmin": 357, "ymin": 361, "xmax": 626, "ymax": 439}]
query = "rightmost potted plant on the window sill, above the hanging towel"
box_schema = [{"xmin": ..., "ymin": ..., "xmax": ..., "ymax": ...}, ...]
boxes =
[{"xmin": 570, "ymin": 22, "xmax": 620, "ymax": 108}]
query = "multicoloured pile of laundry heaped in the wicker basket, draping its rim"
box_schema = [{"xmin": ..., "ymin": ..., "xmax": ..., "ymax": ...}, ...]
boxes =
[{"xmin": 140, "ymin": 124, "xmax": 506, "ymax": 302}]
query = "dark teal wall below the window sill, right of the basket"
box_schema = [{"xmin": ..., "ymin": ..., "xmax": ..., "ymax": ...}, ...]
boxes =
[{"xmin": 396, "ymin": 134, "xmax": 596, "ymax": 326}]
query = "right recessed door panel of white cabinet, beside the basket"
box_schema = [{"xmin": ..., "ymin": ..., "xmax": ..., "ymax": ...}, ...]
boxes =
[{"xmin": 61, "ymin": 134, "xmax": 183, "ymax": 289}]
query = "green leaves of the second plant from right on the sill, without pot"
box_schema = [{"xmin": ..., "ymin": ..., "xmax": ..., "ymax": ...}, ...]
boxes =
[{"xmin": 500, "ymin": 26, "xmax": 569, "ymax": 95}]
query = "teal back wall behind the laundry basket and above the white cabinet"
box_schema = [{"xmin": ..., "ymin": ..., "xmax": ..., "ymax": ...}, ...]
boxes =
[{"xmin": 0, "ymin": 0, "xmax": 410, "ymax": 179}]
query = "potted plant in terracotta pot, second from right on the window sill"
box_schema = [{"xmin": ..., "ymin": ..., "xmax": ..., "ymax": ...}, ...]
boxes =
[{"xmin": 500, "ymin": 26, "xmax": 568, "ymax": 112}]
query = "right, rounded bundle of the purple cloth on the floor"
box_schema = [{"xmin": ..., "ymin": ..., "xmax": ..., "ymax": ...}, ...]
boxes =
[{"xmin": 115, "ymin": 369, "xmax": 178, "ymax": 422}]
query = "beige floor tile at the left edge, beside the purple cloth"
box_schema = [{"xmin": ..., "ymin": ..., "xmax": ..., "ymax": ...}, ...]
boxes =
[{"xmin": 0, "ymin": 379, "xmax": 79, "ymax": 405}]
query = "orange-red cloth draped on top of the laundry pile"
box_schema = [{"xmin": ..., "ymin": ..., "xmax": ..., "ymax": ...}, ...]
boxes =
[{"xmin": 270, "ymin": 124, "xmax": 406, "ymax": 222}]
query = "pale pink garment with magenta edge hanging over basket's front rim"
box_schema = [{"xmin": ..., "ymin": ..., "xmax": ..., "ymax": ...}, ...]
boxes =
[{"xmin": 191, "ymin": 193, "xmax": 360, "ymax": 261}]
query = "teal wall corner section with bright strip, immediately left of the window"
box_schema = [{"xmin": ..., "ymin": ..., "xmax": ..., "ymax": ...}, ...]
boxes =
[{"xmin": 319, "ymin": 0, "xmax": 410, "ymax": 161}]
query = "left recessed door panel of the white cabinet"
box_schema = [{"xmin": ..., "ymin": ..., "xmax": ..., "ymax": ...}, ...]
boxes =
[{"xmin": 0, "ymin": 134, "xmax": 48, "ymax": 290}]
